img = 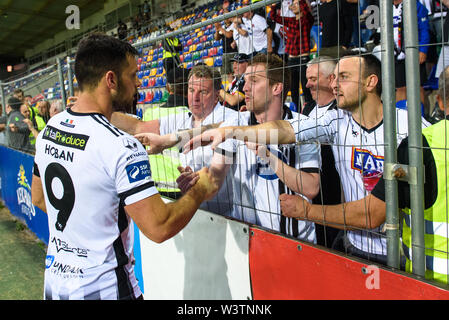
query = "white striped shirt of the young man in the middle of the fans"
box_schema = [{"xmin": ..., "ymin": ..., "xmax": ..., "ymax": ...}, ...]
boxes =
[{"xmin": 224, "ymin": 109, "xmax": 319, "ymax": 243}]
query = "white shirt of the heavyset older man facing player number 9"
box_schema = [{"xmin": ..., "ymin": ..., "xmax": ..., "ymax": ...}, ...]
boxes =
[{"xmin": 159, "ymin": 103, "xmax": 242, "ymax": 216}]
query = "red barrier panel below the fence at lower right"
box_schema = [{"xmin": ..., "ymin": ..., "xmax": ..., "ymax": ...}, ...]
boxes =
[{"xmin": 249, "ymin": 228, "xmax": 449, "ymax": 300}]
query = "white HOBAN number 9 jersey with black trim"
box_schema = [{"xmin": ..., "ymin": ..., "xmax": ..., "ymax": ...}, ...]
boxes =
[{"xmin": 34, "ymin": 109, "xmax": 157, "ymax": 299}]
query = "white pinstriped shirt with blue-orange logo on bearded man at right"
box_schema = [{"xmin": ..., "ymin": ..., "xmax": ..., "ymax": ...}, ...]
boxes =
[{"xmin": 290, "ymin": 109, "xmax": 429, "ymax": 255}]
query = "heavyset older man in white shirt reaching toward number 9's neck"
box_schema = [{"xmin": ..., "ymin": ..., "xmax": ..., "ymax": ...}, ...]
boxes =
[{"xmin": 112, "ymin": 65, "xmax": 238, "ymax": 216}]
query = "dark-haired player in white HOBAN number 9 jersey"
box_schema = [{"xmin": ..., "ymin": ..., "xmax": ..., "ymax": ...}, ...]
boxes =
[{"xmin": 32, "ymin": 34, "xmax": 217, "ymax": 300}]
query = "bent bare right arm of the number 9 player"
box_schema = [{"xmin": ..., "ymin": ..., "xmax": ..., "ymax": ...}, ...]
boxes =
[{"xmin": 125, "ymin": 168, "xmax": 218, "ymax": 243}]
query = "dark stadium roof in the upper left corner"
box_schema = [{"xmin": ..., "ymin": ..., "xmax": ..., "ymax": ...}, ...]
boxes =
[{"xmin": 0, "ymin": 0, "xmax": 105, "ymax": 60}]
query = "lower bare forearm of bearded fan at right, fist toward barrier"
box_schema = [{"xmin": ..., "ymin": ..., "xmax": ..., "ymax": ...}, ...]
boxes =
[{"xmin": 279, "ymin": 194, "xmax": 386, "ymax": 229}]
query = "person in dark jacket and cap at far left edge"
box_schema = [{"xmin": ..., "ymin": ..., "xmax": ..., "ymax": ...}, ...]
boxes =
[{"xmin": 7, "ymin": 97, "xmax": 33, "ymax": 152}]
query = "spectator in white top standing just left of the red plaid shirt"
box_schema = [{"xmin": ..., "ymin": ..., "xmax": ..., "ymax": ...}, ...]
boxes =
[{"xmin": 242, "ymin": 4, "xmax": 273, "ymax": 55}]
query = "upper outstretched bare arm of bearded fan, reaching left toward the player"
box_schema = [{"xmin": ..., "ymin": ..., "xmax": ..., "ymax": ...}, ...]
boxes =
[{"xmin": 184, "ymin": 120, "xmax": 296, "ymax": 153}]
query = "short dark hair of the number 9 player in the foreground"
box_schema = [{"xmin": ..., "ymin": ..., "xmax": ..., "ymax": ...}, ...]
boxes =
[{"xmin": 75, "ymin": 33, "xmax": 138, "ymax": 91}]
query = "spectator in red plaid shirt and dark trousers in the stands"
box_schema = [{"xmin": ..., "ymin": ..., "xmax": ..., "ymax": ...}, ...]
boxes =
[{"xmin": 270, "ymin": 0, "xmax": 313, "ymax": 110}]
